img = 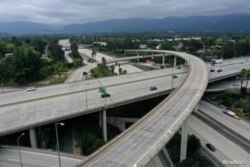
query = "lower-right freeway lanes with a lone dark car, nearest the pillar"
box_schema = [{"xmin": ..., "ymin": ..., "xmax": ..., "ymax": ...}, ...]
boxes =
[{"xmin": 188, "ymin": 116, "xmax": 249, "ymax": 166}]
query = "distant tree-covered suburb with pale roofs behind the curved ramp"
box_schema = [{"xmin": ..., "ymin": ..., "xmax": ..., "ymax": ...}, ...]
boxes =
[{"xmin": 79, "ymin": 33, "xmax": 250, "ymax": 60}]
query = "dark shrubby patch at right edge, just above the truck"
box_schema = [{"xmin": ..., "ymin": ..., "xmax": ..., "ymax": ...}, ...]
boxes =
[{"xmin": 215, "ymin": 93, "xmax": 250, "ymax": 120}]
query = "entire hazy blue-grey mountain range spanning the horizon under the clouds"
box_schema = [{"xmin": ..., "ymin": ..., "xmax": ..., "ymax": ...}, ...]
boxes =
[{"xmin": 0, "ymin": 14, "xmax": 250, "ymax": 35}]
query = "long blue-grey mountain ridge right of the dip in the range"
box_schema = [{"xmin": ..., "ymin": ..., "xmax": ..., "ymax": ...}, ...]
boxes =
[{"xmin": 62, "ymin": 14, "xmax": 250, "ymax": 33}]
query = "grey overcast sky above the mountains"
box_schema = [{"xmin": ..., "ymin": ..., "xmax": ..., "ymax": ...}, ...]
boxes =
[{"xmin": 0, "ymin": 0, "xmax": 250, "ymax": 25}]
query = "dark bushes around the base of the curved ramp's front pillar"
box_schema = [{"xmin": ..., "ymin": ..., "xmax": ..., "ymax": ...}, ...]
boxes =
[{"xmin": 167, "ymin": 133, "xmax": 215, "ymax": 167}]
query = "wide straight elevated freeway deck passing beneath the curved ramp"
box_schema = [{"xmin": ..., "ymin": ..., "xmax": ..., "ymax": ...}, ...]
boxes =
[{"xmin": 0, "ymin": 55, "xmax": 250, "ymax": 136}]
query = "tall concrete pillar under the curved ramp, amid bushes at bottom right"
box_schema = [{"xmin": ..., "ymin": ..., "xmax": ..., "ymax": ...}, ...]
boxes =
[{"xmin": 180, "ymin": 120, "xmax": 188, "ymax": 161}]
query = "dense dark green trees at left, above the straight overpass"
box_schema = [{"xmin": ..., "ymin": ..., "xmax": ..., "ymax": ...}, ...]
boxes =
[{"xmin": 0, "ymin": 37, "xmax": 82, "ymax": 85}]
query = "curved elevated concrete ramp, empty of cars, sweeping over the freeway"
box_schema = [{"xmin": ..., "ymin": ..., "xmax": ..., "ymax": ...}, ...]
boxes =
[{"xmin": 79, "ymin": 50, "xmax": 208, "ymax": 167}]
